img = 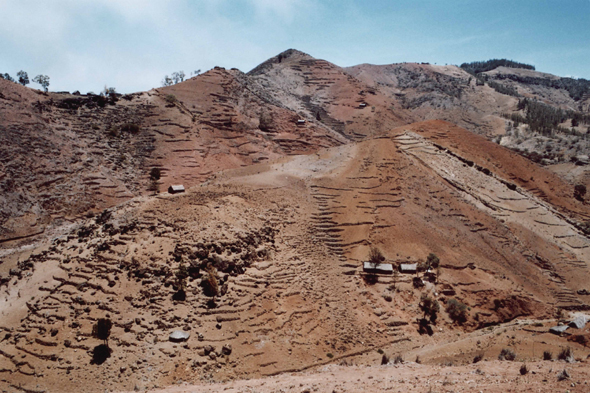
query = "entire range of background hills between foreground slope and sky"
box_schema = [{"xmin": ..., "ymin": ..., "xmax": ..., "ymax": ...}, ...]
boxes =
[{"xmin": 0, "ymin": 49, "xmax": 590, "ymax": 241}]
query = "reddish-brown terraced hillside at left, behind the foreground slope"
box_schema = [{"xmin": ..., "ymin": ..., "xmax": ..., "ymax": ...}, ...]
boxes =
[{"xmin": 0, "ymin": 69, "xmax": 346, "ymax": 241}]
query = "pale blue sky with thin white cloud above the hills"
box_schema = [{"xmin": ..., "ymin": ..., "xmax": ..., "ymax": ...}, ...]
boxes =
[{"xmin": 0, "ymin": 0, "xmax": 590, "ymax": 93}]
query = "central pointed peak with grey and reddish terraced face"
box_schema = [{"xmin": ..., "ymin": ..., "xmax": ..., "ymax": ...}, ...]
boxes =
[{"xmin": 248, "ymin": 49, "xmax": 414, "ymax": 140}]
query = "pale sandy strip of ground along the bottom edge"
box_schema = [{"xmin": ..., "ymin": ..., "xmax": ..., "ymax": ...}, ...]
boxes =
[{"xmin": 120, "ymin": 360, "xmax": 590, "ymax": 393}]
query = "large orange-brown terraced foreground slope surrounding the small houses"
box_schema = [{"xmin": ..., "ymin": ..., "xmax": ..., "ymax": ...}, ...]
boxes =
[{"xmin": 0, "ymin": 121, "xmax": 590, "ymax": 391}]
